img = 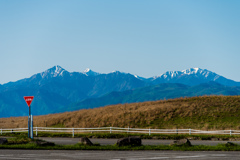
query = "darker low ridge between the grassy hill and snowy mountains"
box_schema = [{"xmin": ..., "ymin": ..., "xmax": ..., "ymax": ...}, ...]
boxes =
[{"xmin": 66, "ymin": 82, "xmax": 240, "ymax": 112}]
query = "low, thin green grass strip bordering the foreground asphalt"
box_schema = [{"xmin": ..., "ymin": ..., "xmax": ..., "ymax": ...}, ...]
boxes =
[{"xmin": 0, "ymin": 143, "xmax": 240, "ymax": 151}]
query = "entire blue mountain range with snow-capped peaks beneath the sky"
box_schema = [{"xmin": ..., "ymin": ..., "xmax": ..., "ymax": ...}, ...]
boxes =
[{"xmin": 0, "ymin": 66, "xmax": 240, "ymax": 117}]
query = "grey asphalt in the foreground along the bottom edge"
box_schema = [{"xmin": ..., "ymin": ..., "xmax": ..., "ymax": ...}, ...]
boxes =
[{"xmin": 0, "ymin": 149, "xmax": 240, "ymax": 160}]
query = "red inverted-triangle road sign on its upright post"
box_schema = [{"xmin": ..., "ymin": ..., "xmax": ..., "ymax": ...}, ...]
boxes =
[{"xmin": 24, "ymin": 96, "xmax": 34, "ymax": 139}]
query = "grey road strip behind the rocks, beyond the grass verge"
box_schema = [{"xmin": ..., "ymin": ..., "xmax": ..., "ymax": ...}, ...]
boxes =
[{"xmin": 36, "ymin": 137, "xmax": 240, "ymax": 146}]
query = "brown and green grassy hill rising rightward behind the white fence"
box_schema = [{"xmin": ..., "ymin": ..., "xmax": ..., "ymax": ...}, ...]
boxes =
[{"xmin": 0, "ymin": 96, "xmax": 240, "ymax": 130}]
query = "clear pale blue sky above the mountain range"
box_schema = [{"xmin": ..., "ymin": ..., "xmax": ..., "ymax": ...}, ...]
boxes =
[{"xmin": 0, "ymin": 0, "xmax": 240, "ymax": 84}]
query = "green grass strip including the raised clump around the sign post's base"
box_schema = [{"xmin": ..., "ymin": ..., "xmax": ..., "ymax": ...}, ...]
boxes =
[{"xmin": 0, "ymin": 136, "xmax": 240, "ymax": 151}]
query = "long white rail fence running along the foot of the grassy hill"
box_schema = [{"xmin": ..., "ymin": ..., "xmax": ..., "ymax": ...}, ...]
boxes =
[{"xmin": 0, "ymin": 127, "xmax": 240, "ymax": 137}]
